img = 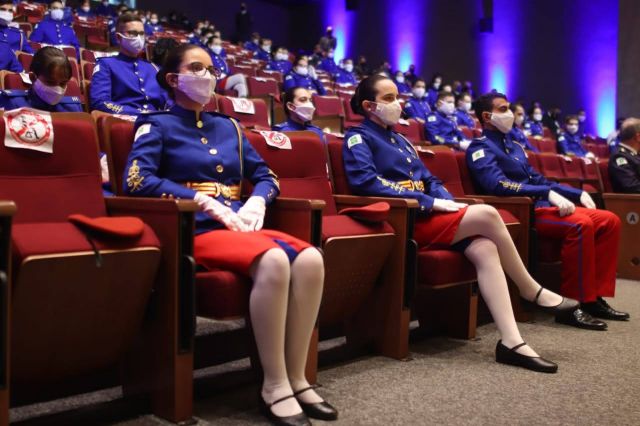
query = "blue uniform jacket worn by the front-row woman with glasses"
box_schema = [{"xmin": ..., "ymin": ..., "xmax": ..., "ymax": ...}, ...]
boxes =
[{"xmin": 123, "ymin": 105, "xmax": 280, "ymax": 234}]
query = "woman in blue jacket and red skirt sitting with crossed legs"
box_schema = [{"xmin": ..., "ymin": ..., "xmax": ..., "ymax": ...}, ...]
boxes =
[{"xmin": 342, "ymin": 75, "xmax": 576, "ymax": 373}]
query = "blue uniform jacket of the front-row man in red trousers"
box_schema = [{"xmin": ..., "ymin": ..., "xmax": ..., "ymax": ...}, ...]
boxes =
[{"xmin": 466, "ymin": 130, "xmax": 582, "ymax": 207}]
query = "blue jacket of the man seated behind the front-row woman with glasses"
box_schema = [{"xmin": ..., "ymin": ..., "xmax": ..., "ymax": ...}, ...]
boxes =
[{"xmin": 90, "ymin": 53, "xmax": 168, "ymax": 115}]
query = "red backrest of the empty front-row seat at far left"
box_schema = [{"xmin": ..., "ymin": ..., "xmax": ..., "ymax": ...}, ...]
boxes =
[{"xmin": 0, "ymin": 113, "xmax": 105, "ymax": 223}]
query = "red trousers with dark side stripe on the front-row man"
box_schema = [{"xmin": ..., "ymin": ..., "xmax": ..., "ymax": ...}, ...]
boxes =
[{"xmin": 536, "ymin": 207, "xmax": 620, "ymax": 302}]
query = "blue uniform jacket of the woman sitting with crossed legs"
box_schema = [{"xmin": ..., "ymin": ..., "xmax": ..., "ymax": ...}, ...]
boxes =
[{"xmin": 342, "ymin": 119, "xmax": 453, "ymax": 215}]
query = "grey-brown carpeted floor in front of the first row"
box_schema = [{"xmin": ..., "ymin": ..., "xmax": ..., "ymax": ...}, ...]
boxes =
[{"xmin": 12, "ymin": 280, "xmax": 640, "ymax": 426}]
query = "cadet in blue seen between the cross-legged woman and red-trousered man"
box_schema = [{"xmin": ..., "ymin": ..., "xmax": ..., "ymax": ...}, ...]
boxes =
[{"xmin": 424, "ymin": 91, "xmax": 471, "ymax": 150}]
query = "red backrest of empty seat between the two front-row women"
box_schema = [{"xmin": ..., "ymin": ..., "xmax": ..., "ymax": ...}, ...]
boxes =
[{"xmin": 245, "ymin": 131, "xmax": 336, "ymax": 215}]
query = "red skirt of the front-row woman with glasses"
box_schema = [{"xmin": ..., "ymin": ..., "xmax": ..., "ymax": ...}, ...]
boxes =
[{"xmin": 193, "ymin": 229, "xmax": 312, "ymax": 275}]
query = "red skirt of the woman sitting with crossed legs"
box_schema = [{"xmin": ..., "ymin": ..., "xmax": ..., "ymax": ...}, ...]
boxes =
[{"xmin": 413, "ymin": 207, "xmax": 467, "ymax": 249}]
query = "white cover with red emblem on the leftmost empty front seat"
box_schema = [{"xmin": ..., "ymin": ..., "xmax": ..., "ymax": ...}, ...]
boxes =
[{"xmin": 3, "ymin": 108, "xmax": 53, "ymax": 154}]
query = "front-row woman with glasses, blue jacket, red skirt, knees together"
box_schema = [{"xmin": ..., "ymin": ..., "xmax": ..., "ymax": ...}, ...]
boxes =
[{"xmin": 123, "ymin": 44, "xmax": 338, "ymax": 425}]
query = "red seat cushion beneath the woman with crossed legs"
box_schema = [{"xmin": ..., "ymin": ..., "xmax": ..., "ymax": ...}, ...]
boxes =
[{"xmin": 418, "ymin": 250, "xmax": 476, "ymax": 286}]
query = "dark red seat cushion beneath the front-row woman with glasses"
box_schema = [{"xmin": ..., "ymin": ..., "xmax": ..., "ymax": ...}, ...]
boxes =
[{"xmin": 196, "ymin": 270, "xmax": 251, "ymax": 319}]
